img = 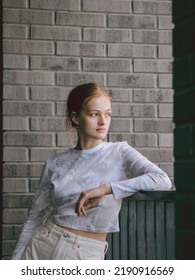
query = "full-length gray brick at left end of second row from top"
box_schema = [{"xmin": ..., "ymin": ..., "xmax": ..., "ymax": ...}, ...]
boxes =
[{"xmin": 3, "ymin": 9, "xmax": 54, "ymax": 24}]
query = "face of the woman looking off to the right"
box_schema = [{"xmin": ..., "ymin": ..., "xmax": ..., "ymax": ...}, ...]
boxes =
[{"xmin": 77, "ymin": 95, "xmax": 111, "ymax": 146}]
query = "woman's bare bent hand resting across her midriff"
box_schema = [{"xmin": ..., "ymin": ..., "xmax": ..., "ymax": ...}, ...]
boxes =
[{"xmin": 75, "ymin": 184, "xmax": 112, "ymax": 216}]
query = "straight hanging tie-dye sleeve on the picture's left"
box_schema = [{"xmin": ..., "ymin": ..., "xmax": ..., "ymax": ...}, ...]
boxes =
[{"xmin": 12, "ymin": 164, "xmax": 52, "ymax": 260}]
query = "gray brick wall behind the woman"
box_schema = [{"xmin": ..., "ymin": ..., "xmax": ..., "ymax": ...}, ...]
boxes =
[{"xmin": 3, "ymin": 0, "xmax": 173, "ymax": 258}]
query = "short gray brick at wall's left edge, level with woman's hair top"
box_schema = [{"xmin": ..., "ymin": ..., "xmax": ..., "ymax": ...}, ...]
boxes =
[{"xmin": 3, "ymin": 85, "xmax": 28, "ymax": 100}]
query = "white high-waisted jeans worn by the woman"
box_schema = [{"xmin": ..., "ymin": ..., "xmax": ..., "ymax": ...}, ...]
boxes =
[{"xmin": 22, "ymin": 220, "xmax": 108, "ymax": 260}]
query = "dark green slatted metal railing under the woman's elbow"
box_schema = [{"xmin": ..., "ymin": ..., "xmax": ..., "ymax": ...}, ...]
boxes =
[{"xmin": 105, "ymin": 191, "xmax": 175, "ymax": 260}]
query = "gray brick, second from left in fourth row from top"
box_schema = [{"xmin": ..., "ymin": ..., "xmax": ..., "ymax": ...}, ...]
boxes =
[{"xmin": 57, "ymin": 42, "xmax": 106, "ymax": 57}]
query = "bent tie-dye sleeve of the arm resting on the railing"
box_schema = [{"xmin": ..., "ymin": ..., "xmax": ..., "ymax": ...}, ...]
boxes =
[{"xmin": 111, "ymin": 142, "xmax": 171, "ymax": 199}]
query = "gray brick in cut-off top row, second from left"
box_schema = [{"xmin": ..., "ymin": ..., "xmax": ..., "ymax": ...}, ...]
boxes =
[{"xmin": 30, "ymin": 0, "xmax": 80, "ymax": 11}]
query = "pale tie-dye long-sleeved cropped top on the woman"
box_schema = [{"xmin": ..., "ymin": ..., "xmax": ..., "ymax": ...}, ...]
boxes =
[{"xmin": 12, "ymin": 142, "xmax": 171, "ymax": 259}]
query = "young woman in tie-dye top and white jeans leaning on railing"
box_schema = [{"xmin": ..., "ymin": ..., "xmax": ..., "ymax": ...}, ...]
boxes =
[{"xmin": 12, "ymin": 83, "xmax": 171, "ymax": 260}]
